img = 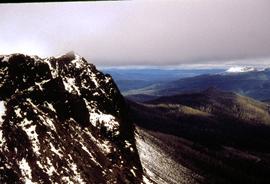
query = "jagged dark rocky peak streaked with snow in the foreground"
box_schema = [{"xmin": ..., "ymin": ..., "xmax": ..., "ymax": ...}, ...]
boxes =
[{"xmin": 0, "ymin": 52, "xmax": 142, "ymax": 183}]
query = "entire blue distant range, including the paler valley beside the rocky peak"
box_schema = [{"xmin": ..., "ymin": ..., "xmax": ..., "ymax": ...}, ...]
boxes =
[{"xmin": 121, "ymin": 69, "xmax": 270, "ymax": 101}]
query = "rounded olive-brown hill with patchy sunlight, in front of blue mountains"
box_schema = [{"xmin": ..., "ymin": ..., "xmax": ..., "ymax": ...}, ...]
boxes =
[{"xmin": 149, "ymin": 88, "xmax": 270, "ymax": 125}]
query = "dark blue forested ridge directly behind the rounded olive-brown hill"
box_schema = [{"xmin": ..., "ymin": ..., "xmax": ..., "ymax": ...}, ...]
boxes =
[{"xmin": 155, "ymin": 69, "xmax": 270, "ymax": 100}]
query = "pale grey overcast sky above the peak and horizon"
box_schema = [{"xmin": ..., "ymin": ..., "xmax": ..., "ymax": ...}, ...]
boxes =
[{"xmin": 0, "ymin": 0, "xmax": 270, "ymax": 66}]
